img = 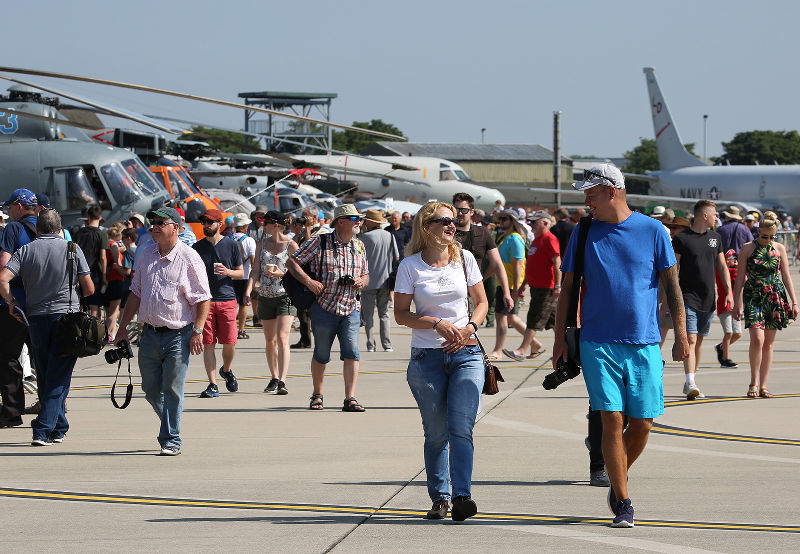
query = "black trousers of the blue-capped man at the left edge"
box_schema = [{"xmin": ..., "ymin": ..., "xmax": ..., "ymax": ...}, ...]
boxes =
[{"xmin": 0, "ymin": 306, "xmax": 28, "ymax": 421}]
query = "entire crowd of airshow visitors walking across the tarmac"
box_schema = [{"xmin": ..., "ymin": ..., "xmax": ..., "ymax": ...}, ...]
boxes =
[{"xmin": 0, "ymin": 174, "xmax": 800, "ymax": 527}]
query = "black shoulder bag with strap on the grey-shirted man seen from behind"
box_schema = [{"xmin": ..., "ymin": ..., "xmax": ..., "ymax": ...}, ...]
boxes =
[{"xmin": 56, "ymin": 241, "xmax": 107, "ymax": 358}]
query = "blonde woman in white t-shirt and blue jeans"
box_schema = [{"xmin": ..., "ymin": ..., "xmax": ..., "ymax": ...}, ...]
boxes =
[{"xmin": 394, "ymin": 202, "xmax": 489, "ymax": 521}]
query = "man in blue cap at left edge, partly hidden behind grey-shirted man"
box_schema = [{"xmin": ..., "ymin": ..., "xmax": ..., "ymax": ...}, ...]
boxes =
[{"xmin": 0, "ymin": 189, "xmax": 37, "ymax": 428}]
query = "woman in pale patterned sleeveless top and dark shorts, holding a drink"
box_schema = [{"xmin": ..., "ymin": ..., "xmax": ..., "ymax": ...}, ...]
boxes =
[{"xmin": 246, "ymin": 211, "xmax": 297, "ymax": 394}]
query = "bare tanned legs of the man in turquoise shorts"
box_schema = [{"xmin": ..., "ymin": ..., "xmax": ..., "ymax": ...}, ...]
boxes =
[{"xmin": 600, "ymin": 412, "xmax": 653, "ymax": 502}]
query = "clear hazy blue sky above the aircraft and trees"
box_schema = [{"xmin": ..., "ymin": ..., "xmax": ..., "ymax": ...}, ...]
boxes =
[{"xmin": 0, "ymin": 0, "xmax": 800, "ymax": 157}]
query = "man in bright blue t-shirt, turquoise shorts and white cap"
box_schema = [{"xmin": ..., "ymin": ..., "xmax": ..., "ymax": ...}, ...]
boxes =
[{"xmin": 553, "ymin": 164, "xmax": 689, "ymax": 527}]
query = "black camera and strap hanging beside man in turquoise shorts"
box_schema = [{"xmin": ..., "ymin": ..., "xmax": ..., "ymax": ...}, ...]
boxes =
[{"xmin": 542, "ymin": 216, "xmax": 592, "ymax": 390}]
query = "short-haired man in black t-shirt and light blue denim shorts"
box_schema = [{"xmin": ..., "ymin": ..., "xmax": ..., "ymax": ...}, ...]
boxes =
[{"xmin": 672, "ymin": 200, "xmax": 733, "ymax": 400}]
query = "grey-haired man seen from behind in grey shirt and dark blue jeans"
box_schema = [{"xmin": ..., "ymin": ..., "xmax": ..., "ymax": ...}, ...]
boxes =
[{"xmin": 0, "ymin": 209, "xmax": 94, "ymax": 446}]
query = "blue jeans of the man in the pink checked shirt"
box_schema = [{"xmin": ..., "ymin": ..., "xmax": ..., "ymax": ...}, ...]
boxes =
[{"xmin": 139, "ymin": 325, "xmax": 192, "ymax": 448}]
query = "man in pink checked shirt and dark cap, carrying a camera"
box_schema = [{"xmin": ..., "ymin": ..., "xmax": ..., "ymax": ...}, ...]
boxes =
[{"xmin": 116, "ymin": 208, "xmax": 211, "ymax": 456}]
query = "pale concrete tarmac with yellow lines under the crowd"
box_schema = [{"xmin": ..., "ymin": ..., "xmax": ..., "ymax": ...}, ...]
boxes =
[{"xmin": 0, "ymin": 270, "xmax": 800, "ymax": 552}]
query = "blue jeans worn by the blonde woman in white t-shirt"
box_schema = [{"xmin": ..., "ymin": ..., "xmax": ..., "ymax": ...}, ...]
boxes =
[{"xmin": 406, "ymin": 346, "xmax": 484, "ymax": 502}]
